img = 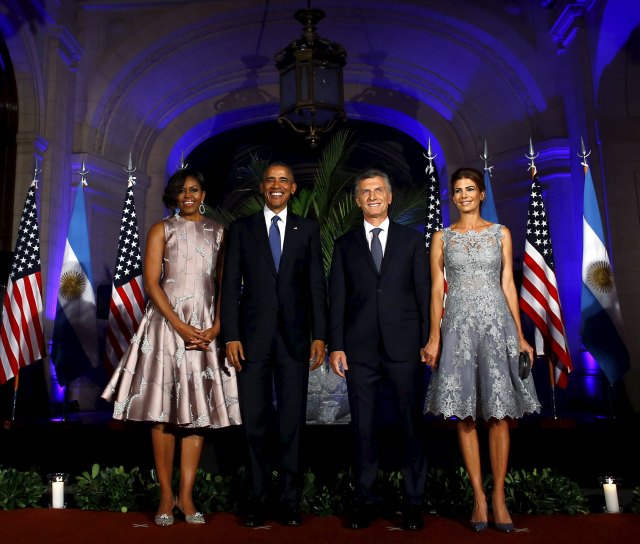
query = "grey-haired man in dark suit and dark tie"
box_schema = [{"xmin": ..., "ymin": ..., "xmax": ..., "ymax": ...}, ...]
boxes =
[{"xmin": 329, "ymin": 169, "xmax": 430, "ymax": 530}]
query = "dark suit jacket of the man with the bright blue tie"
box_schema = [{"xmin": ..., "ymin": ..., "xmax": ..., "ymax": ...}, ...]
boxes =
[{"xmin": 220, "ymin": 210, "xmax": 326, "ymax": 361}]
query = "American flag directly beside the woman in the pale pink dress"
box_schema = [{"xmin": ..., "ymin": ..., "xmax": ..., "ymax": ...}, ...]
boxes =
[{"xmin": 106, "ymin": 176, "xmax": 145, "ymax": 371}]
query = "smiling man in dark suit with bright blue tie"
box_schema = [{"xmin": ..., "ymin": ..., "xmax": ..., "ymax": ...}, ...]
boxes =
[{"xmin": 220, "ymin": 163, "xmax": 326, "ymax": 527}]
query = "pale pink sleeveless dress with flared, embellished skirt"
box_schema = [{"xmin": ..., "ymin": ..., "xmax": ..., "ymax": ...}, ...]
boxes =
[{"xmin": 102, "ymin": 216, "xmax": 240, "ymax": 428}]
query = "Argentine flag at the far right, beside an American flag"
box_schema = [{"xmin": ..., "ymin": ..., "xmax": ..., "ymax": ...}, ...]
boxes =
[{"xmin": 580, "ymin": 165, "xmax": 629, "ymax": 383}]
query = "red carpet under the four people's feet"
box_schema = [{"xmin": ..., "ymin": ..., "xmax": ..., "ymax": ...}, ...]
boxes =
[{"xmin": 0, "ymin": 508, "xmax": 640, "ymax": 544}]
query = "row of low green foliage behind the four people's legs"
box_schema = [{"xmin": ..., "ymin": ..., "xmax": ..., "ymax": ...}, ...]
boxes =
[{"xmin": 0, "ymin": 464, "xmax": 600, "ymax": 516}]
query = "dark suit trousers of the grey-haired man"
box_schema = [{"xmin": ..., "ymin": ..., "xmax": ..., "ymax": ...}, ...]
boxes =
[{"xmin": 346, "ymin": 354, "xmax": 427, "ymax": 506}]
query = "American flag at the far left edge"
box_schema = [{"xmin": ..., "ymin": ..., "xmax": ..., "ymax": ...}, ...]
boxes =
[{"xmin": 0, "ymin": 176, "xmax": 45, "ymax": 383}]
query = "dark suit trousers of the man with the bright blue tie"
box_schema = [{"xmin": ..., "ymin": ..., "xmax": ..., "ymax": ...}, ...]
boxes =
[{"xmin": 237, "ymin": 332, "xmax": 309, "ymax": 508}]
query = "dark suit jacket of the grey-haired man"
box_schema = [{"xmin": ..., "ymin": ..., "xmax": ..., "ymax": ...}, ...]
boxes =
[{"xmin": 329, "ymin": 222, "xmax": 431, "ymax": 363}]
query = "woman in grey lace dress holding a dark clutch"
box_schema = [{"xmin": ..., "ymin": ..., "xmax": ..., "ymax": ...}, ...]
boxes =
[{"xmin": 422, "ymin": 168, "xmax": 540, "ymax": 532}]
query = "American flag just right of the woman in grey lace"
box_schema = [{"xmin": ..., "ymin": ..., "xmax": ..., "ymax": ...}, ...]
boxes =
[{"xmin": 520, "ymin": 166, "xmax": 573, "ymax": 388}]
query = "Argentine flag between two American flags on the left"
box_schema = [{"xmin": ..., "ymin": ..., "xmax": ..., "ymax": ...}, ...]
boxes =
[{"xmin": 51, "ymin": 181, "xmax": 98, "ymax": 385}]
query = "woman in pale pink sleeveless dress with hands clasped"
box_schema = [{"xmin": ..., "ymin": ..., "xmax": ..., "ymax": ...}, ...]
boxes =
[{"xmin": 103, "ymin": 169, "xmax": 240, "ymax": 526}]
